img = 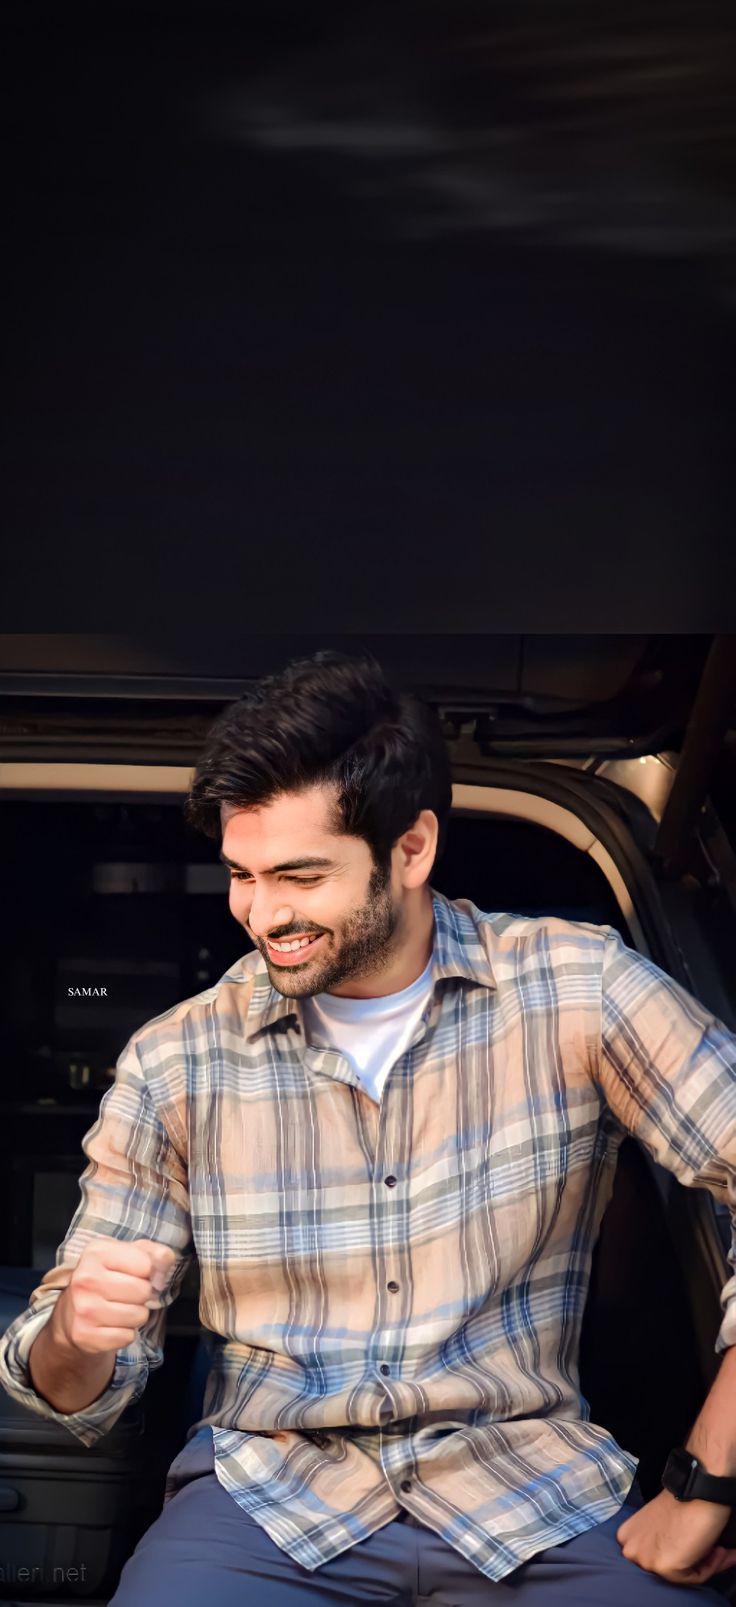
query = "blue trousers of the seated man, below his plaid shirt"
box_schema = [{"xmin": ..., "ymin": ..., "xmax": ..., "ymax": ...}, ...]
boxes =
[{"xmin": 109, "ymin": 1433, "xmax": 725, "ymax": 1607}]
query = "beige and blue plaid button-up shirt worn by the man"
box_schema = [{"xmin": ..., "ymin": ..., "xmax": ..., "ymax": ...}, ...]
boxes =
[{"xmin": 0, "ymin": 890, "xmax": 736, "ymax": 1580}]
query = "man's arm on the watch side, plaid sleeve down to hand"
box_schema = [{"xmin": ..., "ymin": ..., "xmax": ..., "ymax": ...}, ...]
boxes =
[{"xmin": 598, "ymin": 932, "xmax": 736, "ymax": 1585}]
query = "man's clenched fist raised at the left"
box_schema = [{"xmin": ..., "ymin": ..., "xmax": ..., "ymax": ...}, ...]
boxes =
[{"xmin": 55, "ymin": 1239, "xmax": 177, "ymax": 1356}]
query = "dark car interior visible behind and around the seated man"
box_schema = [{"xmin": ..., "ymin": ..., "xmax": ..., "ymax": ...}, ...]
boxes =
[{"xmin": 0, "ymin": 797, "xmax": 736, "ymax": 1604}]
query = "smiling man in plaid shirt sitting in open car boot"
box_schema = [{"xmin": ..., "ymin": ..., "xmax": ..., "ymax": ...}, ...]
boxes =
[{"xmin": 0, "ymin": 654, "xmax": 736, "ymax": 1607}]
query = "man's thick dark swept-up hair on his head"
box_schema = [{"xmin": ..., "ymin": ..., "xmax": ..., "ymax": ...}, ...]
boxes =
[{"xmin": 185, "ymin": 649, "xmax": 452, "ymax": 869}]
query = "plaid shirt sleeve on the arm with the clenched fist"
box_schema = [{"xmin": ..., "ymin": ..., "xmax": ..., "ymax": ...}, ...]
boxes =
[{"xmin": 0, "ymin": 1035, "xmax": 193, "ymax": 1445}]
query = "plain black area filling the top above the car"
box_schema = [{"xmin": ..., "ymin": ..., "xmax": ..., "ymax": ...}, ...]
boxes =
[{"xmin": 0, "ymin": 0, "xmax": 736, "ymax": 640}]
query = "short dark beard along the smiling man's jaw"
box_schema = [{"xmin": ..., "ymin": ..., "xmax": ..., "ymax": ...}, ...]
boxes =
[{"xmin": 259, "ymin": 866, "xmax": 402, "ymax": 998}]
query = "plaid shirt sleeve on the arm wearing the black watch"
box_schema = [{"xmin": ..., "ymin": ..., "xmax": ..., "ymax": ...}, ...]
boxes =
[{"xmin": 599, "ymin": 929, "xmax": 736, "ymax": 1353}]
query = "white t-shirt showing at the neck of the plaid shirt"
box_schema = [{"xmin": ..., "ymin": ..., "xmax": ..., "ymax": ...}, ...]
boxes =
[{"xmin": 302, "ymin": 958, "xmax": 432, "ymax": 1104}]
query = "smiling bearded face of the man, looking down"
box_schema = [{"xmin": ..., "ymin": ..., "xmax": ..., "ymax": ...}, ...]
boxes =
[{"xmin": 220, "ymin": 787, "xmax": 405, "ymax": 998}]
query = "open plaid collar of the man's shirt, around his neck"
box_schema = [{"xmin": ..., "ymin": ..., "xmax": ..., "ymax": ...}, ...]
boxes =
[{"xmin": 244, "ymin": 887, "xmax": 495, "ymax": 1040}]
